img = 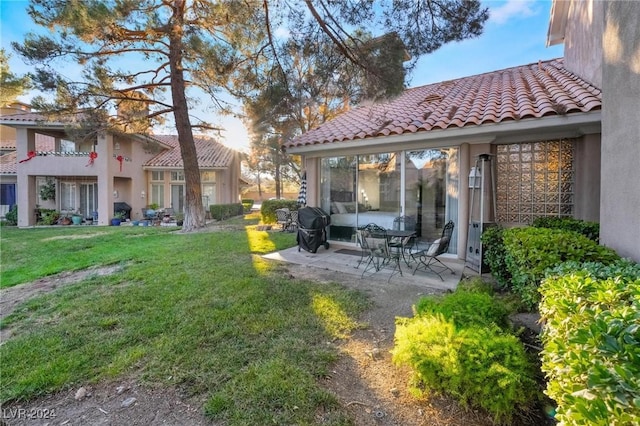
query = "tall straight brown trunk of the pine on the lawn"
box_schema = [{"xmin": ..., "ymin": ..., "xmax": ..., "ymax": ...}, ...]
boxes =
[{"xmin": 169, "ymin": 0, "xmax": 206, "ymax": 232}]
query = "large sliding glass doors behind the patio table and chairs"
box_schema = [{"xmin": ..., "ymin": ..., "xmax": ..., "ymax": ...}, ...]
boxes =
[{"xmin": 321, "ymin": 148, "xmax": 459, "ymax": 253}]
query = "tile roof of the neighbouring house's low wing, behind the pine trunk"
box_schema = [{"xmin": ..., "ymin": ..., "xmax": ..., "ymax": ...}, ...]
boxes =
[{"xmin": 144, "ymin": 135, "xmax": 234, "ymax": 168}]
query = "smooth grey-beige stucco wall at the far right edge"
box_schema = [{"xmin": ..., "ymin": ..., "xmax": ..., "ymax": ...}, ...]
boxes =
[{"xmin": 600, "ymin": 1, "xmax": 640, "ymax": 262}]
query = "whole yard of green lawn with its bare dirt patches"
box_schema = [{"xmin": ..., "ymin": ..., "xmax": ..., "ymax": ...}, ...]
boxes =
[{"xmin": 0, "ymin": 216, "xmax": 544, "ymax": 425}]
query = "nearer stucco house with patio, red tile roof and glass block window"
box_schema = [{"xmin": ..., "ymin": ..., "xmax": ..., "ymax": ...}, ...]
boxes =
[{"xmin": 284, "ymin": 1, "xmax": 640, "ymax": 260}]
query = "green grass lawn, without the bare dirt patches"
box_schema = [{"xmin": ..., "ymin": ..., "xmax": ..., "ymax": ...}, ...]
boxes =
[{"xmin": 0, "ymin": 219, "xmax": 369, "ymax": 425}]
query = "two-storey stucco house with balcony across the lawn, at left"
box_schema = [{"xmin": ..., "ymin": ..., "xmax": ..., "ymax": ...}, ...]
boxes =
[{"xmin": 0, "ymin": 106, "xmax": 240, "ymax": 227}]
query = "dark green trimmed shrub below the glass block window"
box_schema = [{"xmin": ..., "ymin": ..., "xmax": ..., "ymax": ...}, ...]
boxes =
[{"xmin": 503, "ymin": 227, "xmax": 619, "ymax": 309}]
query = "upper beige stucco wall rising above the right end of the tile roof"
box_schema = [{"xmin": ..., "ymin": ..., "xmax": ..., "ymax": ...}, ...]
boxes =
[{"xmin": 564, "ymin": 0, "xmax": 606, "ymax": 88}]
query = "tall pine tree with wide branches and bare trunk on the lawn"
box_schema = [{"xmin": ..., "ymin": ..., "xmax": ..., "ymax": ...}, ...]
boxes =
[{"xmin": 13, "ymin": 0, "xmax": 487, "ymax": 231}]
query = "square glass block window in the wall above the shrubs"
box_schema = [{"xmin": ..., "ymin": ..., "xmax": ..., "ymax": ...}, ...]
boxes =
[{"xmin": 496, "ymin": 139, "xmax": 575, "ymax": 224}]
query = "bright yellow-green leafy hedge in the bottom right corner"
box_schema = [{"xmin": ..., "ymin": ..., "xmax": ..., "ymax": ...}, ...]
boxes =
[{"xmin": 540, "ymin": 260, "xmax": 640, "ymax": 426}]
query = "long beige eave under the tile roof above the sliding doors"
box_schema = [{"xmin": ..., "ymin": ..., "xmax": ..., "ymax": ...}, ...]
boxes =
[{"xmin": 287, "ymin": 110, "xmax": 602, "ymax": 156}]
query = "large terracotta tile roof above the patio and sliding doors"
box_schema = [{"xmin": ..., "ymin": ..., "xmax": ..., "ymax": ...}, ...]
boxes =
[{"xmin": 284, "ymin": 58, "xmax": 602, "ymax": 148}]
